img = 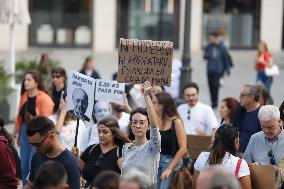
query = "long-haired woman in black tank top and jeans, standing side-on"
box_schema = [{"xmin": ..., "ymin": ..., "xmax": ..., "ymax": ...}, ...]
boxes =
[{"xmin": 152, "ymin": 92, "xmax": 187, "ymax": 189}]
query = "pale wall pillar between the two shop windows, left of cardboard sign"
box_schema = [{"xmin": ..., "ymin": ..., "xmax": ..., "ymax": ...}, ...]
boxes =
[{"xmin": 93, "ymin": 0, "xmax": 117, "ymax": 52}]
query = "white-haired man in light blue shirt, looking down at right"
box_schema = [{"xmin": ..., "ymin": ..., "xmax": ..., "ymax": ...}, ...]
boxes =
[{"xmin": 244, "ymin": 105, "xmax": 284, "ymax": 172}]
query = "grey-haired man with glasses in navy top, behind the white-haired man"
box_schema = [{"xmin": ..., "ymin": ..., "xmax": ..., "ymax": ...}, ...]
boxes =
[{"xmin": 233, "ymin": 85, "xmax": 261, "ymax": 153}]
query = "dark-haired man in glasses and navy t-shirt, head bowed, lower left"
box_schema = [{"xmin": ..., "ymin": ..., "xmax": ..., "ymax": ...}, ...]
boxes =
[{"xmin": 24, "ymin": 116, "xmax": 80, "ymax": 189}]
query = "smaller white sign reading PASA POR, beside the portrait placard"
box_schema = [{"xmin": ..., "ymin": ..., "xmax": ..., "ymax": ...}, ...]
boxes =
[{"xmin": 95, "ymin": 79, "xmax": 125, "ymax": 104}]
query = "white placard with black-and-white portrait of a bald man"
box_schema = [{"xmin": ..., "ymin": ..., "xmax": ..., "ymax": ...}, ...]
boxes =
[{"xmin": 67, "ymin": 71, "xmax": 96, "ymax": 121}]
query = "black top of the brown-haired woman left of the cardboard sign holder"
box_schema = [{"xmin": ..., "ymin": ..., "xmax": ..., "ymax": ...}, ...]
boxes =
[{"xmin": 80, "ymin": 144, "xmax": 120, "ymax": 187}]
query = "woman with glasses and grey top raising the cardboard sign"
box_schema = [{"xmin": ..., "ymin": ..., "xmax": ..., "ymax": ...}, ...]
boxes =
[{"xmin": 119, "ymin": 81, "xmax": 161, "ymax": 183}]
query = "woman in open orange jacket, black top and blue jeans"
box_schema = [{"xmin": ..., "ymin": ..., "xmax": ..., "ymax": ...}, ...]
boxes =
[{"xmin": 15, "ymin": 70, "xmax": 54, "ymax": 185}]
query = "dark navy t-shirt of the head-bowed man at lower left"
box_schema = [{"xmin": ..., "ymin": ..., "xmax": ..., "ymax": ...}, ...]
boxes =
[{"xmin": 29, "ymin": 149, "xmax": 80, "ymax": 189}]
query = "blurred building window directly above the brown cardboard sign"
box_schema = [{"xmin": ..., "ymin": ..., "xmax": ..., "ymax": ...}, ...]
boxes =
[{"xmin": 117, "ymin": 0, "xmax": 179, "ymax": 48}]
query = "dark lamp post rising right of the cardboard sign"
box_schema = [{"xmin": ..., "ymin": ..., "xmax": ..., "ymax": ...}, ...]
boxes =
[{"xmin": 179, "ymin": 0, "xmax": 192, "ymax": 98}]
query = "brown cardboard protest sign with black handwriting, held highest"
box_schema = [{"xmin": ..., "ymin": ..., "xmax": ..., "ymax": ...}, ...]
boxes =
[{"xmin": 117, "ymin": 39, "xmax": 173, "ymax": 86}]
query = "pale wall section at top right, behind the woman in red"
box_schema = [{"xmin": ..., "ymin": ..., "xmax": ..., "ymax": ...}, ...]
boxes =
[{"xmin": 260, "ymin": 0, "xmax": 283, "ymax": 51}]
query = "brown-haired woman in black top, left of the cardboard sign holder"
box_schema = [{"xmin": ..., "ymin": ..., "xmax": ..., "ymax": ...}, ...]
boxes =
[{"xmin": 80, "ymin": 116, "xmax": 129, "ymax": 187}]
